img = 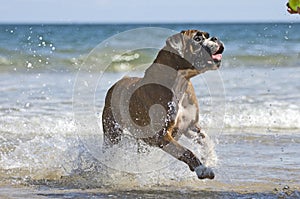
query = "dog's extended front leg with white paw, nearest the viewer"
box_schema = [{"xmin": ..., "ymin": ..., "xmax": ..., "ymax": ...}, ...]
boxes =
[{"xmin": 162, "ymin": 129, "xmax": 215, "ymax": 179}]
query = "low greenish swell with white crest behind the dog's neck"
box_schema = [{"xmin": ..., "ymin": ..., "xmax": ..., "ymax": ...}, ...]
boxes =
[{"xmin": 0, "ymin": 53, "xmax": 300, "ymax": 72}]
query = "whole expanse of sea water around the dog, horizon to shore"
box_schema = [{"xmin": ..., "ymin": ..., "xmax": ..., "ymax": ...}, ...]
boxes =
[{"xmin": 0, "ymin": 23, "xmax": 300, "ymax": 198}]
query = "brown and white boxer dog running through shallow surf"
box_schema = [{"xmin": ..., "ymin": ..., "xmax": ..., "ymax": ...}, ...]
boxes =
[{"xmin": 102, "ymin": 30, "xmax": 224, "ymax": 179}]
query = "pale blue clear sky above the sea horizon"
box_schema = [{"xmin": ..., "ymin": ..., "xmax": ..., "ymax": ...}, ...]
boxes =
[{"xmin": 0, "ymin": 0, "xmax": 300, "ymax": 23}]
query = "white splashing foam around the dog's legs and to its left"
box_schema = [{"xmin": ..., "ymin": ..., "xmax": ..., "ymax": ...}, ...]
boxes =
[{"xmin": 0, "ymin": 111, "xmax": 216, "ymax": 186}]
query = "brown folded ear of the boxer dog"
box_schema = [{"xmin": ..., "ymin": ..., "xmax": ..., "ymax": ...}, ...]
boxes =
[{"xmin": 166, "ymin": 31, "xmax": 185, "ymax": 58}]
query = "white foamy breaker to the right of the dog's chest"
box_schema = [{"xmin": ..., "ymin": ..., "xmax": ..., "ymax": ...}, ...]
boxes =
[{"xmin": 224, "ymin": 102, "xmax": 300, "ymax": 130}]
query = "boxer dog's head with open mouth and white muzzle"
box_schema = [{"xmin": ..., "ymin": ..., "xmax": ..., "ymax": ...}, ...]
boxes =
[{"xmin": 165, "ymin": 30, "xmax": 224, "ymax": 74}]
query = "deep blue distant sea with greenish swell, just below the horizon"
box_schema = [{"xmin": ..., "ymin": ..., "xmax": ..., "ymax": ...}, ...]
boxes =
[{"xmin": 0, "ymin": 23, "xmax": 300, "ymax": 72}]
